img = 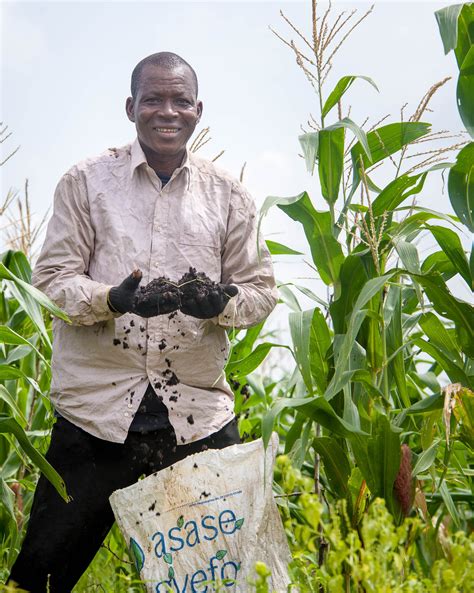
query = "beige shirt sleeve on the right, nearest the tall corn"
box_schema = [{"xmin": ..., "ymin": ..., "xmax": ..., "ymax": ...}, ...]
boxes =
[{"xmin": 217, "ymin": 183, "xmax": 278, "ymax": 328}]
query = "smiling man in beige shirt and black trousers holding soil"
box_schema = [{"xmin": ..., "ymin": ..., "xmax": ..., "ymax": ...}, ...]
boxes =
[{"xmin": 10, "ymin": 53, "xmax": 276, "ymax": 593}]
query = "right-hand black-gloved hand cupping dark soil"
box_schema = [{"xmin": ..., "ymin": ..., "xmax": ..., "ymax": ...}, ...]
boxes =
[{"xmin": 180, "ymin": 284, "xmax": 239, "ymax": 319}]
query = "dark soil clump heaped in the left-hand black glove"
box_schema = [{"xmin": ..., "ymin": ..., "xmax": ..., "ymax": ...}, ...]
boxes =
[{"xmin": 134, "ymin": 276, "xmax": 181, "ymax": 317}]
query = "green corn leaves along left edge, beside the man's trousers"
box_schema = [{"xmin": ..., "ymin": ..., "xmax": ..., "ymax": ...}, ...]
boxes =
[{"xmin": 0, "ymin": 251, "xmax": 68, "ymax": 579}]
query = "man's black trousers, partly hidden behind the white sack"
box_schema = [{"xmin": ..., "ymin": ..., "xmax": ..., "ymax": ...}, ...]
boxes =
[{"xmin": 10, "ymin": 418, "xmax": 240, "ymax": 593}]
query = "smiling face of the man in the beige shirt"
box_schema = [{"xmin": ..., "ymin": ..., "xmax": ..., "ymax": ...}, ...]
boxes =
[{"xmin": 126, "ymin": 64, "xmax": 202, "ymax": 167}]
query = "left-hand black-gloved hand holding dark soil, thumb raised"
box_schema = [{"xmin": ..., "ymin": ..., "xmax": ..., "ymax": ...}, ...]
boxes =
[{"xmin": 107, "ymin": 270, "xmax": 180, "ymax": 317}]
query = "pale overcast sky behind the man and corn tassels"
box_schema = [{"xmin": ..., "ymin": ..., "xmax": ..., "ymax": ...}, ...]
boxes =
[{"xmin": 0, "ymin": 0, "xmax": 466, "ymax": 320}]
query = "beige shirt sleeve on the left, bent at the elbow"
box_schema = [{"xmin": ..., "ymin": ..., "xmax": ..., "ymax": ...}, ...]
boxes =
[{"xmin": 32, "ymin": 170, "xmax": 117, "ymax": 325}]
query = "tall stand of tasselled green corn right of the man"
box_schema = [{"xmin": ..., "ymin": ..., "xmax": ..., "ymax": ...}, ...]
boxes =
[{"xmin": 261, "ymin": 0, "xmax": 474, "ymax": 540}]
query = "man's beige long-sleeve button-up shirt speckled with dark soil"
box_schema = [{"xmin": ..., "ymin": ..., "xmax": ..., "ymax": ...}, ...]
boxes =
[{"xmin": 33, "ymin": 140, "xmax": 277, "ymax": 444}]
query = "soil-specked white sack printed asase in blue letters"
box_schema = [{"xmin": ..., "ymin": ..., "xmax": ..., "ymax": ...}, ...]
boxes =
[{"xmin": 110, "ymin": 434, "xmax": 290, "ymax": 593}]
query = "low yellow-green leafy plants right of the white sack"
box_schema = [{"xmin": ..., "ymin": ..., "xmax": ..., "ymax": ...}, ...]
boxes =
[{"xmin": 274, "ymin": 456, "xmax": 474, "ymax": 593}]
